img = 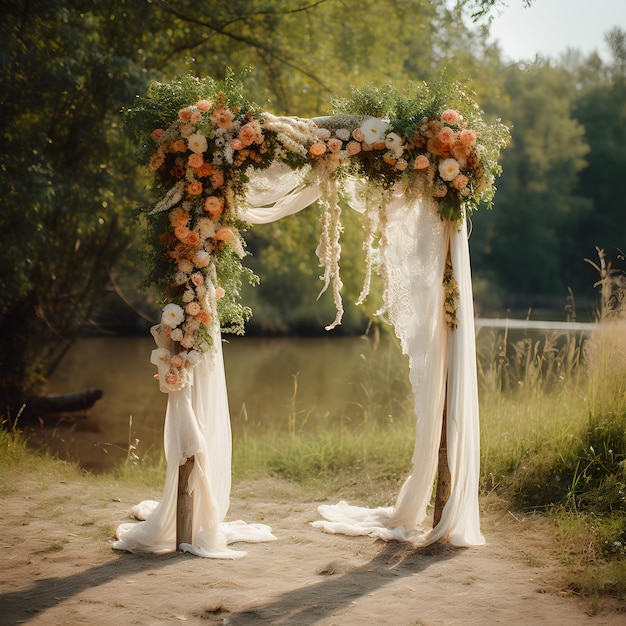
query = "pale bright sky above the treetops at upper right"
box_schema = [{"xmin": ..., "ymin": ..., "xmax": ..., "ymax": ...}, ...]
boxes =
[{"xmin": 491, "ymin": 0, "xmax": 626, "ymax": 61}]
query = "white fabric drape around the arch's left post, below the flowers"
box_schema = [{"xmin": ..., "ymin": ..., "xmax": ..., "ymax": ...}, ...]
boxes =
[{"xmin": 113, "ymin": 332, "xmax": 275, "ymax": 559}]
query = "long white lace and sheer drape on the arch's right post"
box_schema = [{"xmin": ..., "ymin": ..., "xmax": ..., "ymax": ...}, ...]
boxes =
[{"xmin": 313, "ymin": 211, "xmax": 485, "ymax": 546}]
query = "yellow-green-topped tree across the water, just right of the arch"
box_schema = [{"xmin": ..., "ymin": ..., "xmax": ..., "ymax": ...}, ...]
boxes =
[{"xmin": 471, "ymin": 61, "xmax": 591, "ymax": 307}]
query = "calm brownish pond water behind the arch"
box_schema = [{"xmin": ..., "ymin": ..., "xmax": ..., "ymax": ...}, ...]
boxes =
[{"xmin": 27, "ymin": 320, "xmax": 592, "ymax": 472}]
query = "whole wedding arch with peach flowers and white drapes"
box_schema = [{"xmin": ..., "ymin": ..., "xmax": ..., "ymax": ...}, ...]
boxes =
[{"xmin": 114, "ymin": 75, "xmax": 508, "ymax": 558}]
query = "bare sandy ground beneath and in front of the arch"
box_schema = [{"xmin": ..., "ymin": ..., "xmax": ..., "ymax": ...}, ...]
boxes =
[{"xmin": 0, "ymin": 472, "xmax": 626, "ymax": 626}]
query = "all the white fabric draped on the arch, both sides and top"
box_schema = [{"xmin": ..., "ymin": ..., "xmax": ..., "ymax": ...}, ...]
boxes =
[{"xmin": 114, "ymin": 165, "xmax": 484, "ymax": 558}]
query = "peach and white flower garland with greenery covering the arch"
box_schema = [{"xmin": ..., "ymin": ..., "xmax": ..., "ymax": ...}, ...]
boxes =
[{"xmin": 127, "ymin": 74, "xmax": 508, "ymax": 391}]
